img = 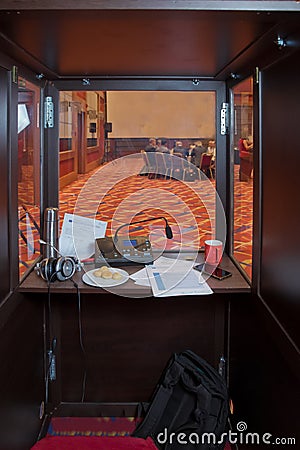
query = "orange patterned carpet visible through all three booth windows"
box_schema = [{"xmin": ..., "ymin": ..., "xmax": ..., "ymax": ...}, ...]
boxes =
[{"xmin": 19, "ymin": 157, "xmax": 253, "ymax": 278}]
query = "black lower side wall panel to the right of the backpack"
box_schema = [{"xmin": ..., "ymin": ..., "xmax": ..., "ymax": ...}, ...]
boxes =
[{"xmin": 229, "ymin": 297, "xmax": 300, "ymax": 444}]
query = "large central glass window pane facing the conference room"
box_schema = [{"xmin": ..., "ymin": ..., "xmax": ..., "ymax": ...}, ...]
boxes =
[{"xmin": 59, "ymin": 91, "xmax": 220, "ymax": 258}]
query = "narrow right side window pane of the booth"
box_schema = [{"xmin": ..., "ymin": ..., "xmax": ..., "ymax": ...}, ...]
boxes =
[{"xmin": 233, "ymin": 77, "xmax": 254, "ymax": 279}]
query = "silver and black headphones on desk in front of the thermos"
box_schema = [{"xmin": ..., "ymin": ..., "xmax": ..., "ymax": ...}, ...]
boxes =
[{"xmin": 34, "ymin": 256, "xmax": 81, "ymax": 282}]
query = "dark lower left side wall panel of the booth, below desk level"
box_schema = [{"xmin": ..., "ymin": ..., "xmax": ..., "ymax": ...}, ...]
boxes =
[{"xmin": 0, "ymin": 294, "xmax": 45, "ymax": 450}]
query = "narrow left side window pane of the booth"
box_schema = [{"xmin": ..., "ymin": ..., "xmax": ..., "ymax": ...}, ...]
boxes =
[{"xmin": 18, "ymin": 78, "xmax": 40, "ymax": 277}]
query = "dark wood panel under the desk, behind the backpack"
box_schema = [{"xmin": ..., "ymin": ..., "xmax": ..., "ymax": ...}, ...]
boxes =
[{"xmin": 43, "ymin": 294, "xmax": 227, "ymax": 403}]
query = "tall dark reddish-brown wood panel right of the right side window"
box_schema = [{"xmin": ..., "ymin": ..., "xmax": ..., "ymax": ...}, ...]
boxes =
[{"xmin": 260, "ymin": 47, "xmax": 300, "ymax": 345}]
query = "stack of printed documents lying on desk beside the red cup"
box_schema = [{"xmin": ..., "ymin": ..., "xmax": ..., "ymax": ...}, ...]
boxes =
[{"xmin": 130, "ymin": 256, "xmax": 213, "ymax": 297}]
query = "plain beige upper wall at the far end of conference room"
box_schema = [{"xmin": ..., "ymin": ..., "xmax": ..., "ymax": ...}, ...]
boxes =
[{"xmin": 107, "ymin": 91, "xmax": 216, "ymax": 138}]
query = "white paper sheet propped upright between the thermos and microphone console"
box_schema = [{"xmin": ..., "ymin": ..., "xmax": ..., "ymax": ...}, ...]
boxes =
[{"xmin": 59, "ymin": 213, "xmax": 107, "ymax": 261}]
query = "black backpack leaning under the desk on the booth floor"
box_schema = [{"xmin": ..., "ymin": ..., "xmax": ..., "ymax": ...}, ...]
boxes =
[{"xmin": 133, "ymin": 350, "xmax": 229, "ymax": 450}]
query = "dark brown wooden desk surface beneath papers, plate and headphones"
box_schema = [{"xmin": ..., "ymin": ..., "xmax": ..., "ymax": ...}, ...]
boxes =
[{"xmin": 19, "ymin": 254, "xmax": 250, "ymax": 297}]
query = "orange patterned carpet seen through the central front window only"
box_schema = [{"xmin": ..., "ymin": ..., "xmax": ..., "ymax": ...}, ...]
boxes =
[{"xmin": 60, "ymin": 161, "xmax": 215, "ymax": 248}]
